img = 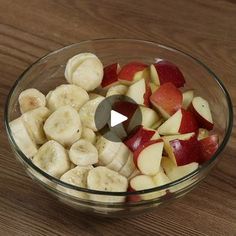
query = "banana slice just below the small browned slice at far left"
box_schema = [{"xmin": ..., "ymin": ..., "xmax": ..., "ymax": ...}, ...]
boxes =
[{"xmin": 21, "ymin": 107, "xmax": 50, "ymax": 144}]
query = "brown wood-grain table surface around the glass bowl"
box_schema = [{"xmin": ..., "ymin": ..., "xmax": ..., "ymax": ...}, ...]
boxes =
[{"xmin": 0, "ymin": 0, "xmax": 236, "ymax": 236}]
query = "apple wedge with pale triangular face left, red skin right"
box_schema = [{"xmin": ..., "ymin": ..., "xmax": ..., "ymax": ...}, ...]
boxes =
[{"xmin": 158, "ymin": 108, "xmax": 198, "ymax": 135}]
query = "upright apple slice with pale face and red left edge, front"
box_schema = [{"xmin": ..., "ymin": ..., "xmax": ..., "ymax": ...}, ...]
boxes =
[{"xmin": 134, "ymin": 139, "xmax": 164, "ymax": 175}]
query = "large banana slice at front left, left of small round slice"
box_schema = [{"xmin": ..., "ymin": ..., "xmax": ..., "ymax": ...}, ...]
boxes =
[{"xmin": 33, "ymin": 140, "xmax": 70, "ymax": 178}]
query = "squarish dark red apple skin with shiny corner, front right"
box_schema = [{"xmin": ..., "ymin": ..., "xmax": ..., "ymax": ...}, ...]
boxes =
[{"xmin": 170, "ymin": 135, "xmax": 201, "ymax": 166}]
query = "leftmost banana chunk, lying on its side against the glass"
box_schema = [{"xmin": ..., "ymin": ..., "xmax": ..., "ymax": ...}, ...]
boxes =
[{"xmin": 9, "ymin": 117, "xmax": 38, "ymax": 158}]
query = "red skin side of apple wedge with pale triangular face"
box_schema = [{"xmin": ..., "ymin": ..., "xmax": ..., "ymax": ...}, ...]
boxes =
[{"xmin": 179, "ymin": 108, "xmax": 199, "ymax": 134}]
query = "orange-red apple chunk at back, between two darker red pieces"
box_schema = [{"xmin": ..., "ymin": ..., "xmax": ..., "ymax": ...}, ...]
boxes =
[{"xmin": 118, "ymin": 62, "xmax": 149, "ymax": 85}]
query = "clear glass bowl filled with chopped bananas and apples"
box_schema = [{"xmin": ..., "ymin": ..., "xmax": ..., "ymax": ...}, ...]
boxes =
[{"xmin": 5, "ymin": 39, "xmax": 232, "ymax": 216}]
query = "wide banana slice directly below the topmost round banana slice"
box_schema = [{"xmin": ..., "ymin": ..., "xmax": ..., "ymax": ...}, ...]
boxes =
[{"xmin": 46, "ymin": 84, "xmax": 89, "ymax": 111}]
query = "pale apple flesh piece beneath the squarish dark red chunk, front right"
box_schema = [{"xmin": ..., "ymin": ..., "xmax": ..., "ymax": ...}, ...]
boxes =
[{"xmin": 161, "ymin": 157, "xmax": 199, "ymax": 181}]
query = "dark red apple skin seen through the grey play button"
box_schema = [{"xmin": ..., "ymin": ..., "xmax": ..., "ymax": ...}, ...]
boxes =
[{"xmin": 113, "ymin": 101, "xmax": 139, "ymax": 129}]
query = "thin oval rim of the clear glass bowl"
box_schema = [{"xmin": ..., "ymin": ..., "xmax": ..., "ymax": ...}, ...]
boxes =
[{"xmin": 4, "ymin": 38, "xmax": 233, "ymax": 196}]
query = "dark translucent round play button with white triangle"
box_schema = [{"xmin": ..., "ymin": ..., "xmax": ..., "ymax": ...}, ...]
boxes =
[{"xmin": 95, "ymin": 95, "xmax": 142, "ymax": 142}]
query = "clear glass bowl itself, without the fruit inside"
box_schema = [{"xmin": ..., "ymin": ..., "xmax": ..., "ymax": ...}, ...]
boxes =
[{"xmin": 5, "ymin": 39, "xmax": 233, "ymax": 217}]
